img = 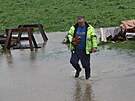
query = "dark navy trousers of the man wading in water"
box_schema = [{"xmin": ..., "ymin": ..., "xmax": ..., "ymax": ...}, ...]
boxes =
[{"xmin": 70, "ymin": 51, "xmax": 91, "ymax": 76}]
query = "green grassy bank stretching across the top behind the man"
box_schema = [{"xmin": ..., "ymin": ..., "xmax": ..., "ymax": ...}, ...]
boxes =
[{"xmin": 0, "ymin": 0, "xmax": 135, "ymax": 33}]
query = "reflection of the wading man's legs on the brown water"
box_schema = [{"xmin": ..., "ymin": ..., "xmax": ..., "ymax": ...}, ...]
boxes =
[{"xmin": 73, "ymin": 79, "xmax": 94, "ymax": 101}]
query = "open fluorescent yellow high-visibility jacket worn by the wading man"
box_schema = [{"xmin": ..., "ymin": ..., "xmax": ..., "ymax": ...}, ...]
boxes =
[{"xmin": 68, "ymin": 23, "xmax": 97, "ymax": 54}]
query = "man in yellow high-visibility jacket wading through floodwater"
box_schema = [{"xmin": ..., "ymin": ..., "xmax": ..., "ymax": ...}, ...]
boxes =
[{"xmin": 68, "ymin": 16, "xmax": 97, "ymax": 79}]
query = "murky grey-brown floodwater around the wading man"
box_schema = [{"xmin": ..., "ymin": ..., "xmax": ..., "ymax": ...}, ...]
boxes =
[{"xmin": 0, "ymin": 32, "xmax": 135, "ymax": 101}]
